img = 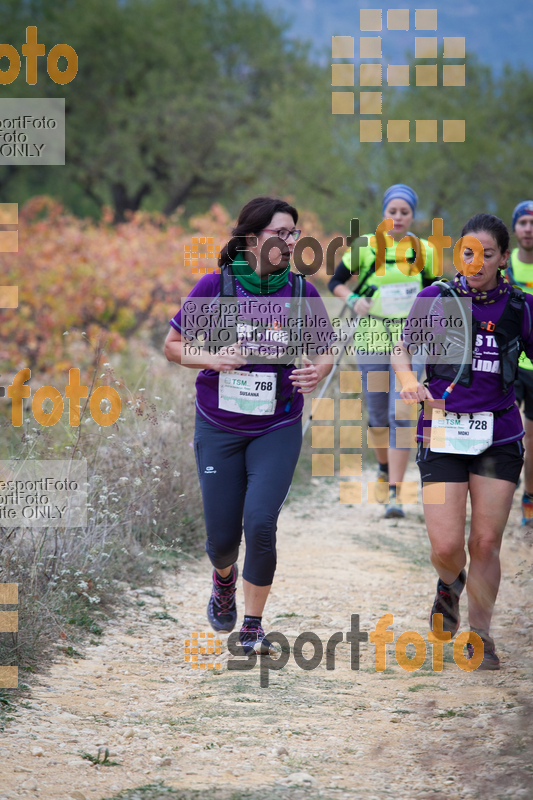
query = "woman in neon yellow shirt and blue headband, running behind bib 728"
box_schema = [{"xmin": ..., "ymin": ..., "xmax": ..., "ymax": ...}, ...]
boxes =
[{"xmin": 328, "ymin": 183, "xmax": 437, "ymax": 519}]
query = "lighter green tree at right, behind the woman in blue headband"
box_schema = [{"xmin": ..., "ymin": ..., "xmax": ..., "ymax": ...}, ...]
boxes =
[{"xmin": 340, "ymin": 56, "xmax": 533, "ymax": 237}]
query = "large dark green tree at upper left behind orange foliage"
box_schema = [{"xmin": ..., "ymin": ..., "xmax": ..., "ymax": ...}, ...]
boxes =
[{"xmin": 0, "ymin": 0, "xmax": 340, "ymax": 221}]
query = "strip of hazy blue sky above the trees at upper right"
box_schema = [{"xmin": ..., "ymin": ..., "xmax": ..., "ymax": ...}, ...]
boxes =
[{"xmin": 256, "ymin": 0, "xmax": 533, "ymax": 72}]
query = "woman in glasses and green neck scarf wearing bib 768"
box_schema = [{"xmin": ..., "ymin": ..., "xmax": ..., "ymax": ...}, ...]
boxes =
[{"xmin": 165, "ymin": 197, "xmax": 333, "ymax": 654}]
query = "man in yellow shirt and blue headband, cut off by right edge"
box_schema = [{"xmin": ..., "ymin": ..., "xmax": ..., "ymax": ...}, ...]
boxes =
[{"xmin": 507, "ymin": 200, "xmax": 533, "ymax": 527}]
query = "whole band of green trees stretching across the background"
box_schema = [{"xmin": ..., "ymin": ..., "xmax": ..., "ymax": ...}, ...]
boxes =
[{"xmin": 0, "ymin": 0, "xmax": 533, "ymax": 236}]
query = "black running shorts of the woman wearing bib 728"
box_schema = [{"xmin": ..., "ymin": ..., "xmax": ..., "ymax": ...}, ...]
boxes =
[{"xmin": 416, "ymin": 441, "xmax": 524, "ymax": 484}]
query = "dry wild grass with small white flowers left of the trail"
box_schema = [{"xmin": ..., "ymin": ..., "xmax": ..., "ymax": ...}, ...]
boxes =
[{"xmin": 0, "ymin": 334, "xmax": 203, "ymax": 671}]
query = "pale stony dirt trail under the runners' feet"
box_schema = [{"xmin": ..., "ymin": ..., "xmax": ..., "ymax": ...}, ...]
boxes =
[{"xmin": 0, "ymin": 472, "xmax": 533, "ymax": 800}]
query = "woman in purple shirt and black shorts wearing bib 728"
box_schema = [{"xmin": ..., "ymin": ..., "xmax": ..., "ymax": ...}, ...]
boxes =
[{"xmin": 393, "ymin": 214, "xmax": 533, "ymax": 669}]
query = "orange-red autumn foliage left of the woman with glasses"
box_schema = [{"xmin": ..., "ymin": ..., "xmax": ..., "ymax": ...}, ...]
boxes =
[{"xmin": 0, "ymin": 197, "xmax": 332, "ymax": 372}]
